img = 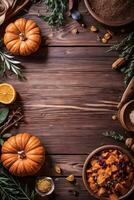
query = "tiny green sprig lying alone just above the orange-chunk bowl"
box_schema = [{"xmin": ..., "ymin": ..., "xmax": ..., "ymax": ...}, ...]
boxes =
[{"xmin": 102, "ymin": 131, "xmax": 125, "ymax": 141}]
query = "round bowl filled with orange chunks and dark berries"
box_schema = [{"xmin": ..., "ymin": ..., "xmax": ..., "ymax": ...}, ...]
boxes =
[{"xmin": 82, "ymin": 145, "xmax": 134, "ymax": 200}]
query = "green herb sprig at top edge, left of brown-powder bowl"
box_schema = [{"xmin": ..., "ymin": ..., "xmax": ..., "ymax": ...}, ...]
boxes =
[{"xmin": 40, "ymin": 0, "xmax": 67, "ymax": 26}]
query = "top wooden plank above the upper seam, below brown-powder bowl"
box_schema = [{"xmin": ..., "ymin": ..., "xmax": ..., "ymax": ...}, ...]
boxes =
[{"xmin": 25, "ymin": 0, "xmax": 133, "ymax": 46}]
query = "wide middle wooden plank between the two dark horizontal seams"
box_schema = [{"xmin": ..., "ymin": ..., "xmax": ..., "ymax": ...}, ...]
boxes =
[{"xmin": 1, "ymin": 47, "xmax": 124, "ymax": 154}]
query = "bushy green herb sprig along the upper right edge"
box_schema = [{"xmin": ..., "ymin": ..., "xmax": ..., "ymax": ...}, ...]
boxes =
[{"xmin": 109, "ymin": 32, "xmax": 134, "ymax": 85}]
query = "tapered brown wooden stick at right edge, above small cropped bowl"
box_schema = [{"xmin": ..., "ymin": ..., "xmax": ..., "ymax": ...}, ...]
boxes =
[{"xmin": 117, "ymin": 77, "xmax": 134, "ymax": 109}]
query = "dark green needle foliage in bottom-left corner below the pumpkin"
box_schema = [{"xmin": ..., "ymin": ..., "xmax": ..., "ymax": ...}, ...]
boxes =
[{"xmin": 0, "ymin": 168, "xmax": 35, "ymax": 200}]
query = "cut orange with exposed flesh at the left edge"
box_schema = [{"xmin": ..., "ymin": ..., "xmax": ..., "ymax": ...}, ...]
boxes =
[{"xmin": 0, "ymin": 83, "xmax": 16, "ymax": 104}]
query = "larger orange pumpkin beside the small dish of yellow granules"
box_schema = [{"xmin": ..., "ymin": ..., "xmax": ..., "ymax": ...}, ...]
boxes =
[{"xmin": 1, "ymin": 133, "xmax": 45, "ymax": 176}]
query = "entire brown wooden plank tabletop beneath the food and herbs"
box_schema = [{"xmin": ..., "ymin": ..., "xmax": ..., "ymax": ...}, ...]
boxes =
[{"xmin": 1, "ymin": 1, "xmax": 133, "ymax": 200}]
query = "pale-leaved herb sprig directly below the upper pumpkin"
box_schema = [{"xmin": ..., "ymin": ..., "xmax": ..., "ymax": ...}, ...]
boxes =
[{"xmin": 0, "ymin": 40, "xmax": 25, "ymax": 79}]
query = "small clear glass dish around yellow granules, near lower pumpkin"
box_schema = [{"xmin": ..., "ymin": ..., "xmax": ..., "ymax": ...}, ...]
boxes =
[{"xmin": 35, "ymin": 177, "xmax": 55, "ymax": 197}]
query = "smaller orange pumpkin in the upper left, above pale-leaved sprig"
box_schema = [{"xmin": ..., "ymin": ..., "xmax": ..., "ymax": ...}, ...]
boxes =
[{"xmin": 4, "ymin": 18, "xmax": 41, "ymax": 56}]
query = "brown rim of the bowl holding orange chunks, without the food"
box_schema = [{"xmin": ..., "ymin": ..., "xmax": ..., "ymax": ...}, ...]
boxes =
[{"xmin": 82, "ymin": 145, "xmax": 134, "ymax": 200}]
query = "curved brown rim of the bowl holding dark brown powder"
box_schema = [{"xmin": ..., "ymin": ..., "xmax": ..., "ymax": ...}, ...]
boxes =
[{"xmin": 84, "ymin": 0, "xmax": 134, "ymax": 27}]
